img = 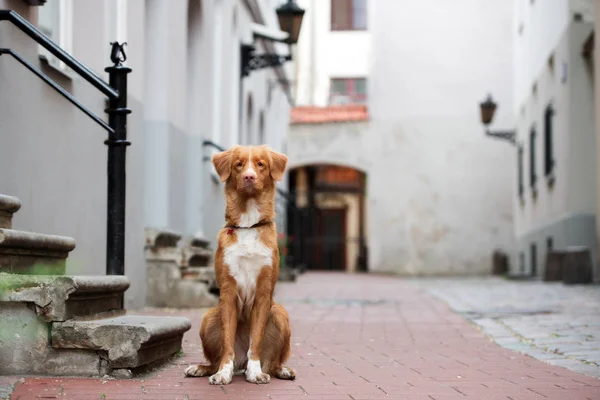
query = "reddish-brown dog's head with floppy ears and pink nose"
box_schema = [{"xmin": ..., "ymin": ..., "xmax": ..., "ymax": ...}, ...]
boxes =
[{"xmin": 212, "ymin": 146, "xmax": 288, "ymax": 196}]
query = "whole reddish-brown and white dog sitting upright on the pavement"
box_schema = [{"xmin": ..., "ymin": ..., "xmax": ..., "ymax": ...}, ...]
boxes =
[{"xmin": 185, "ymin": 146, "xmax": 296, "ymax": 385}]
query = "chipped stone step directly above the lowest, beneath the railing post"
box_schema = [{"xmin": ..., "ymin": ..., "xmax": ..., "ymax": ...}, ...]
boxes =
[{"xmin": 0, "ymin": 273, "xmax": 129, "ymax": 322}]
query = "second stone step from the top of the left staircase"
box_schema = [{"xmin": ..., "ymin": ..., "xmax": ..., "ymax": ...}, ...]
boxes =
[{"xmin": 0, "ymin": 228, "xmax": 75, "ymax": 275}]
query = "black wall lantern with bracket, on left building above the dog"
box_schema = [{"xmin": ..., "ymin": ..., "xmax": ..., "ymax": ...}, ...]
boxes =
[{"xmin": 241, "ymin": 0, "xmax": 304, "ymax": 78}]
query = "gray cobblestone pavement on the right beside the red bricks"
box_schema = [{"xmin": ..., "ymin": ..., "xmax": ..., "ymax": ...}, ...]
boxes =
[{"xmin": 413, "ymin": 277, "xmax": 600, "ymax": 378}]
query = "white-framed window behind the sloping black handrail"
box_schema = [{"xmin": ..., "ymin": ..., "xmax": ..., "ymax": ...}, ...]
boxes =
[{"xmin": 38, "ymin": 0, "xmax": 73, "ymax": 72}]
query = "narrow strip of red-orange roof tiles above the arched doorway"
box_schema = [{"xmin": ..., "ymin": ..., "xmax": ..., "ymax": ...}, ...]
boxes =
[{"xmin": 290, "ymin": 105, "xmax": 369, "ymax": 124}]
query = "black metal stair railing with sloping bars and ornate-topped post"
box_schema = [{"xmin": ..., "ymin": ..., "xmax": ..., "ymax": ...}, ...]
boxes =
[{"xmin": 0, "ymin": 10, "xmax": 131, "ymax": 275}]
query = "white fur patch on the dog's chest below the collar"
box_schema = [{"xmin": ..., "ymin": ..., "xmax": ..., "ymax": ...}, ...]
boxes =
[{"xmin": 224, "ymin": 228, "xmax": 273, "ymax": 314}]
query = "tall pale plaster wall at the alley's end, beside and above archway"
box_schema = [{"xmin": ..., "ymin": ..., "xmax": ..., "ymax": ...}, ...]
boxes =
[{"xmin": 289, "ymin": 0, "xmax": 516, "ymax": 274}]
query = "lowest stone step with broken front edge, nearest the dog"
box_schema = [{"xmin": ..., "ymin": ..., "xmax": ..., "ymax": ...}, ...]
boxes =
[{"xmin": 51, "ymin": 315, "xmax": 191, "ymax": 370}]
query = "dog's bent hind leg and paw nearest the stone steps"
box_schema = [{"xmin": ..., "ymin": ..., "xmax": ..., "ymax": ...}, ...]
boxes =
[{"xmin": 185, "ymin": 307, "xmax": 223, "ymax": 376}]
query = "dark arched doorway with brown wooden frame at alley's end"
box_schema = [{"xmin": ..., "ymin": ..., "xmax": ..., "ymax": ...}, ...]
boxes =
[{"xmin": 287, "ymin": 164, "xmax": 368, "ymax": 272}]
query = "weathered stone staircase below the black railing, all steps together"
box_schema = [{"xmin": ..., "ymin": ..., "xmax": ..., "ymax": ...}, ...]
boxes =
[{"xmin": 0, "ymin": 195, "xmax": 191, "ymax": 378}]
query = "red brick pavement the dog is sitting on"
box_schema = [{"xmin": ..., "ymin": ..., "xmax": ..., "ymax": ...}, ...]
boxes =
[{"xmin": 4, "ymin": 273, "xmax": 600, "ymax": 400}]
